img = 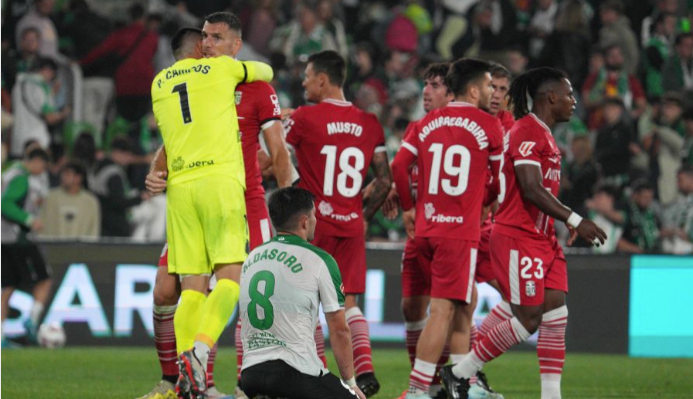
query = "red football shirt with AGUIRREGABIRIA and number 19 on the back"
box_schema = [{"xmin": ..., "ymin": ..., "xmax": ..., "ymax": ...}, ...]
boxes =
[{"xmin": 392, "ymin": 102, "xmax": 503, "ymax": 241}]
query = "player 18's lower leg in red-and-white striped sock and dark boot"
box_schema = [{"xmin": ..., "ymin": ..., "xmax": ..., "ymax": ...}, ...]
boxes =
[{"xmin": 344, "ymin": 294, "xmax": 380, "ymax": 397}]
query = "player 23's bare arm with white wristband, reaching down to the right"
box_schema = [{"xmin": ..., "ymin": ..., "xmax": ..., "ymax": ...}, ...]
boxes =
[{"xmin": 515, "ymin": 163, "xmax": 606, "ymax": 245}]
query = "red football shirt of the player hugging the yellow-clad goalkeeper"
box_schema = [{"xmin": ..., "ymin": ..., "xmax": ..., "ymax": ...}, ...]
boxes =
[{"xmin": 235, "ymin": 81, "xmax": 281, "ymax": 198}]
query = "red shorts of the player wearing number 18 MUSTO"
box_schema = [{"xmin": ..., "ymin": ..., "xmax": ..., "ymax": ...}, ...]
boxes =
[{"xmin": 312, "ymin": 231, "xmax": 366, "ymax": 294}]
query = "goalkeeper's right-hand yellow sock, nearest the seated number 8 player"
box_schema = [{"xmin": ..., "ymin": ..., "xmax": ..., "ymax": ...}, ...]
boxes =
[{"xmin": 196, "ymin": 278, "xmax": 241, "ymax": 348}]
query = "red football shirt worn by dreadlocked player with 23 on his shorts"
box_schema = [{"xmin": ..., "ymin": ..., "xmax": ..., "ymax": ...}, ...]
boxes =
[{"xmin": 494, "ymin": 114, "xmax": 561, "ymax": 238}]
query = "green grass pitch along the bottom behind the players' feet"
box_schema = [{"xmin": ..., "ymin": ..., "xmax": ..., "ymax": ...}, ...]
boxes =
[{"xmin": 1, "ymin": 346, "xmax": 693, "ymax": 399}]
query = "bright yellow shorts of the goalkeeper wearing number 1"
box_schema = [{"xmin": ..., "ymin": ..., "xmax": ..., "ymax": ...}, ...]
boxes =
[{"xmin": 166, "ymin": 175, "xmax": 250, "ymax": 275}]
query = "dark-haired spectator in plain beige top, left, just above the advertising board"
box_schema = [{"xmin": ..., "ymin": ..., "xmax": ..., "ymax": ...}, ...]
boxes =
[{"xmin": 41, "ymin": 161, "xmax": 101, "ymax": 239}]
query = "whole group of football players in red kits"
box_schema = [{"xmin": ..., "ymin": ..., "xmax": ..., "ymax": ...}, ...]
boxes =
[{"xmin": 145, "ymin": 12, "xmax": 606, "ymax": 399}]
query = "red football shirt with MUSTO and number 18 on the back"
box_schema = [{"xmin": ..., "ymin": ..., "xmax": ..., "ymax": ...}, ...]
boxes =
[{"xmin": 285, "ymin": 99, "xmax": 386, "ymax": 237}]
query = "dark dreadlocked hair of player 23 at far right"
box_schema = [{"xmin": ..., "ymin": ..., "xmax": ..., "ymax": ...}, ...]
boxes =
[{"xmin": 508, "ymin": 67, "xmax": 568, "ymax": 119}]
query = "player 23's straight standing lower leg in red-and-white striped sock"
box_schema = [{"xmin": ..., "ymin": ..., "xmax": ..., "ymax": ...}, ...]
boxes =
[{"xmin": 537, "ymin": 289, "xmax": 568, "ymax": 399}]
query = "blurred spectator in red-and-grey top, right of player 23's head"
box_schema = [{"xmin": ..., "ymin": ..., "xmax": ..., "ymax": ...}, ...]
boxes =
[{"xmin": 582, "ymin": 45, "xmax": 647, "ymax": 129}]
